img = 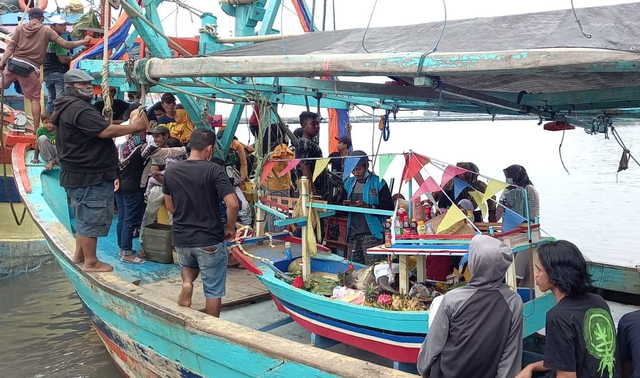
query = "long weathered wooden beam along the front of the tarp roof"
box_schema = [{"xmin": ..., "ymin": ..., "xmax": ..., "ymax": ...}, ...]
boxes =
[{"xmin": 142, "ymin": 48, "xmax": 640, "ymax": 78}]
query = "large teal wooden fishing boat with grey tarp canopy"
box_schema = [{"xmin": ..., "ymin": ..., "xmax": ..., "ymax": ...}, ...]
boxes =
[{"xmin": 13, "ymin": 0, "xmax": 640, "ymax": 377}]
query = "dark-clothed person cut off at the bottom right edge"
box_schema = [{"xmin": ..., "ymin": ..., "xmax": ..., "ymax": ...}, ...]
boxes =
[{"xmin": 618, "ymin": 310, "xmax": 640, "ymax": 378}]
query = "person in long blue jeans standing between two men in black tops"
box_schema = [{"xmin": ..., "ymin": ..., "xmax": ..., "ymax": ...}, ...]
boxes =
[{"xmin": 116, "ymin": 124, "xmax": 187, "ymax": 264}]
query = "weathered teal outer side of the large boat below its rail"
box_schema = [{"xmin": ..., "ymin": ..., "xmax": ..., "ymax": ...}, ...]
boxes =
[{"xmin": 54, "ymin": 247, "xmax": 334, "ymax": 377}]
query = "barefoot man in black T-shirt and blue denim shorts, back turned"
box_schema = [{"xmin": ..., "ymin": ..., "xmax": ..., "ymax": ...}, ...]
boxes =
[{"xmin": 162, "ymin": 129, "xmax": 239, "ymax": 317}]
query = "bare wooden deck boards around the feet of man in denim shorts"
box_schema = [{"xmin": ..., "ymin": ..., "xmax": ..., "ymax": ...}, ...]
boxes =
[{"xmin": 142, "ymin": 268, "xmax": 269, "ymax": 310}]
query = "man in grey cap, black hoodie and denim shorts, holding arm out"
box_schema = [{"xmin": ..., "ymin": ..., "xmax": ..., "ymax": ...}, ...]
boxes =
[{"xmin": 51, "ymin": 70, "xmax": 147, "ymax": 272}]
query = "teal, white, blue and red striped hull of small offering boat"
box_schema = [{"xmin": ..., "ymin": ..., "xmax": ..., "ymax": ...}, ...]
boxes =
[{"xmin": 252, "ymin": 255, "xmax": 555, "ymax": 364}]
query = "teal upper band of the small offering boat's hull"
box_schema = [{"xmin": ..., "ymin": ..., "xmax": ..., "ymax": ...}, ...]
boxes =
[{"xmin": 258, "ymin": 258, "xmax": 429, "ymax": 333}]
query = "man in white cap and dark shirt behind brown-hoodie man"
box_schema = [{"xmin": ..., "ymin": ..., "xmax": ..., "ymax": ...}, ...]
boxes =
[{"xmin": 43, "ymin": 15, "xmax": 71, "ymax": 112}]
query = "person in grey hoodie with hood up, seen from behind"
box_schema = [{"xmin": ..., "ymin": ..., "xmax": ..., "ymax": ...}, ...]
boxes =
[{"xmin": 418, "ymin": 235, "xmax": 522, "ymax": 378}]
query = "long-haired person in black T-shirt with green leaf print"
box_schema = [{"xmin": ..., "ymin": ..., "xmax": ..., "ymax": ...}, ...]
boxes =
[{"xmin": 520, "ymin": 240, "xmax": 621, "ymax": 378}]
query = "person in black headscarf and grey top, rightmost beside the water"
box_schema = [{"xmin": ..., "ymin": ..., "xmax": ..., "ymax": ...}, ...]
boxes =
[{"xmin": 496, "ymin": 164, "xmax": 540, "ymax": 221}]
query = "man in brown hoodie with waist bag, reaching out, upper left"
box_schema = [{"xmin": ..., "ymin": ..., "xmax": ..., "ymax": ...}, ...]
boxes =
[{"xmin": 0, "ymin": 8, "xmax": 91, "ymax": 129}]
